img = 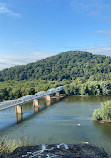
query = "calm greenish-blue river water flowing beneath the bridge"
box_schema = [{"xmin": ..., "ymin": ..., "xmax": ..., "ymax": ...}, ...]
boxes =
[{"xmin": 0, "ymin": 96, "xmax": 111, "ymax": 153}]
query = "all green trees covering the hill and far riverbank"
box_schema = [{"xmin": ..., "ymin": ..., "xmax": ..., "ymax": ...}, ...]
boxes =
[{"xmin": 0, "ymin": 51, "xmax": 111, "ymax": 101}]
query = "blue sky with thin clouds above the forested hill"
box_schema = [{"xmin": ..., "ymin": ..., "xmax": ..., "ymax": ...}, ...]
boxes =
[{"xmin": 0, "ymin": 0, "xmax": 111, "ymax": 70}]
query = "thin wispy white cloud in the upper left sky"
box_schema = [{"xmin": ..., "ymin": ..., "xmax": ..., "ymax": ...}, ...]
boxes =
[{"xmin": 0, "ymin": 3, "xmax": 21, "ymax": 17}]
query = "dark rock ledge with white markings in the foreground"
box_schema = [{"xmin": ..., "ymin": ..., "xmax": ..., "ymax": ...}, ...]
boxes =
[{"xmin": 0, "ymin": 144, "xmax": 111, "ymax": 158}]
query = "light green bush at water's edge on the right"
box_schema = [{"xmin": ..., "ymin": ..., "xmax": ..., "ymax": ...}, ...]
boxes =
[{"xmin": 93, "ymin": 101, "xmax": 111, "ymax": 120}]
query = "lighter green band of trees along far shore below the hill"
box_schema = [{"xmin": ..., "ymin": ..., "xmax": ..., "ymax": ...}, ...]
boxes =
[{"xmin": 0, "ymin": 78, "xmax": 111, "ymax": 101}]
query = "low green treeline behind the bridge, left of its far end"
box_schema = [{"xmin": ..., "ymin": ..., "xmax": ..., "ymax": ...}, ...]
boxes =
[{"xmin": 0, "ymin": 80, "xmax": 69, "ymax": 101}]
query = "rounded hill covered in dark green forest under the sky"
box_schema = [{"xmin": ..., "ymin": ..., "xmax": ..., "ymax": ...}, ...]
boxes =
[{"xmin": 0, "ymin": 51, "xmax": 111, "ymax": 82}]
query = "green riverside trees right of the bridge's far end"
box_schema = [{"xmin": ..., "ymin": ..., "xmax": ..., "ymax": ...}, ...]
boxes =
[{"xmin": 65, "ymin": 80, "xmax": 111, "ymax": 96}]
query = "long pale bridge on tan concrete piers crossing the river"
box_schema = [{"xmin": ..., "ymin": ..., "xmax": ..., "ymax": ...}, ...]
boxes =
[{"xmin": 0, "ymin": 86, "xmax": 64, "ymax": 122}]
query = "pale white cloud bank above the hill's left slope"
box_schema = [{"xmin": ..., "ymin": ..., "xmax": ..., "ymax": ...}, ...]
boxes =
[{"xmin": 0, "ymin": 52, "xmax": 54, "ymax": 70}]
